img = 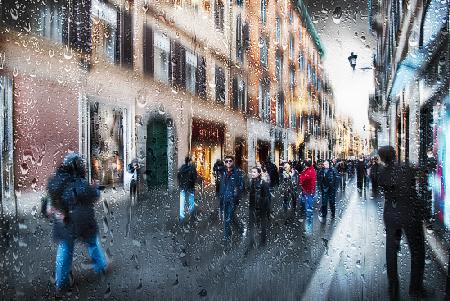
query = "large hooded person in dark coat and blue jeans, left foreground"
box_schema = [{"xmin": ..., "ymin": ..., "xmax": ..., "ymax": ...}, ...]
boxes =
[{"xmin": 47, "ymin": 153, "xmax": 109, "ymax": 290}]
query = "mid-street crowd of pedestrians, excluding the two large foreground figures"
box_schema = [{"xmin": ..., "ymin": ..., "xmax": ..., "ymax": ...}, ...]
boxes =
[{"xmin": 178, "ymin": 152, "xmax": 384, "ymax": 249}]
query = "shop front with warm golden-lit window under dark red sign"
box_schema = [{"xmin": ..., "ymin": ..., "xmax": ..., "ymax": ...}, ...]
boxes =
[{"xmin": 191, "ymin": 118, "xmax": 225, "ymax": 183}]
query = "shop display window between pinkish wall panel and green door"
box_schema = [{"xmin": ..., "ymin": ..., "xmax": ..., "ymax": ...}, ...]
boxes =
[{"xmin": 90, "ymin": 102, "xmax": 126, "ymax": 187}]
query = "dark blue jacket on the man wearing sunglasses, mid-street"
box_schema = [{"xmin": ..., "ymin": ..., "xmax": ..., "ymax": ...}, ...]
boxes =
[{"xmin": 219, "ymin": 168, "xmax": 244, "ymax": 203}]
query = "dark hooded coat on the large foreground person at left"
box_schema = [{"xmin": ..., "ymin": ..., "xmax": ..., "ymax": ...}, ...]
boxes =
[{"xmin": 47, "ymin": 171, "xmax": 100, "ymax": 241}]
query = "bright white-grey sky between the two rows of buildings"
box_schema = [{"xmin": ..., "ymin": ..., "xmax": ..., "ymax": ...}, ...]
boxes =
[{"xmin": 305, "ymin": 0, "xmax": 376, "ymax": 131}]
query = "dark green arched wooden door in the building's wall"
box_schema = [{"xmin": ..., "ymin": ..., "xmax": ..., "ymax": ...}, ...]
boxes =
[{"xmin": 146, "ymin": 120, "xmax": 168, "ymax": 187}]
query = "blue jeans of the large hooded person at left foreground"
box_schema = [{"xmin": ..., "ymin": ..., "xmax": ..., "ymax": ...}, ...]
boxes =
[{"xmin": 55, "ymin": 235, "xmax": 108, "ymax": 289}]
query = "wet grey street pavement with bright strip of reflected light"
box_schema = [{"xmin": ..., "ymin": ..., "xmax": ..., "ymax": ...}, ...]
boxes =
[{"xmin": 1, "ymin": 180, "xmax": 445, "ymax": 300}]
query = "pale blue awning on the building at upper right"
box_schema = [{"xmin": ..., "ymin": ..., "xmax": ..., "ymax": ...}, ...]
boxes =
[{"xmin": 389, "ymin": 0, "xmax": 448, "ymax": 97}]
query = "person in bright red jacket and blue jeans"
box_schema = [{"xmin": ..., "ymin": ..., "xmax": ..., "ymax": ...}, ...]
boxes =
[{"xmin": 299, "ymin": 160, "xmax": 316, "ymax": 234}]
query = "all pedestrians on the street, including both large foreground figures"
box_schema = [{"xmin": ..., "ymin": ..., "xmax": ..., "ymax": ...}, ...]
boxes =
[{"xmin": 42, "ymin": 146, "xmax": 432, "ymax": 299}]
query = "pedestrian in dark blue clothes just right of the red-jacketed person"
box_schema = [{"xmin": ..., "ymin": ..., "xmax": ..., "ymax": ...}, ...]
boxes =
[{"xmin": 318, "ymin": 160, "xmax": 338, "ymax": 223}]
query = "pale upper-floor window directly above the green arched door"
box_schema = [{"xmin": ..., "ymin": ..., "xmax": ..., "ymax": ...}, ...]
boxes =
[{"xmin": 154, "ymin": 31, "xmax": 170, "ymax": 83}]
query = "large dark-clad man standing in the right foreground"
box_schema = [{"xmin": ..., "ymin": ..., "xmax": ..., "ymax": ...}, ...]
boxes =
[{"xmin": 378, "ymin": 146, "xmax": 425, "ymax": 300}]
